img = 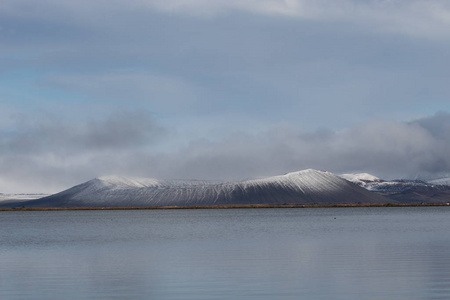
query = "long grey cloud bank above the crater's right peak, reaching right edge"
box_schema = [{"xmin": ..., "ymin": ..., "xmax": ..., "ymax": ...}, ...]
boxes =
[{"xmin": 142, "ymin": 114, "xmax": 450, "ymax": 179}]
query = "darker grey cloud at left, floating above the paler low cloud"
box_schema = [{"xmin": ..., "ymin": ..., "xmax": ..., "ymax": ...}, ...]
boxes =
[{"xmin": 0, "ymin": 111, "xmax": 164, "ymax": 155}]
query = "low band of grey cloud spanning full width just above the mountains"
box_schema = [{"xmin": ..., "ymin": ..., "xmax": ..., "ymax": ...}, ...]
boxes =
[{"xmin": 0, "ymin": 112, "xmax": 450, "ymax": 192}]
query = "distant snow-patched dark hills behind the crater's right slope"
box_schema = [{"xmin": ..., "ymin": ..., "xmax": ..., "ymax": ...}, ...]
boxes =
[{"xmin": 340, "ymin": 173, "xmax": 450, "ymax": 203}]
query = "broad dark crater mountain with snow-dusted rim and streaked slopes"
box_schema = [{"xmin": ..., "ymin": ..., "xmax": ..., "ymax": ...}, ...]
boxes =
[{"xmin": 1, "ymin": 169, "xmax": 392, "ymax": 207}]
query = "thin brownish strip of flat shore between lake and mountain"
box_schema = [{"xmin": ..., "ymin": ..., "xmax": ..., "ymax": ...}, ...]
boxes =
[{"xmin": 0, "ymin": 203, "xmax": 449, "ymax": 211}]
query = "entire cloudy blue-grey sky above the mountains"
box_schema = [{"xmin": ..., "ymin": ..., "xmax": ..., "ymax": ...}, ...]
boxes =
[{"xmin": 0, "ymin": 0, "xmax": 450, "ymax": 193}]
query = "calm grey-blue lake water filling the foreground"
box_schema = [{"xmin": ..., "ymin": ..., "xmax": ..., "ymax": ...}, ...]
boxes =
[{"xmin": 0, "ymin": 207, "xmax": 450, "ymax": 300}]
